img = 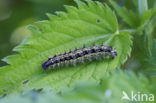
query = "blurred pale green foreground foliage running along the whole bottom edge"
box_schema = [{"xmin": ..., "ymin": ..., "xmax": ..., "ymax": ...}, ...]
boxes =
[{"xmin": 0, "ymin": 71, "xmax": 155, "ymax": 103}]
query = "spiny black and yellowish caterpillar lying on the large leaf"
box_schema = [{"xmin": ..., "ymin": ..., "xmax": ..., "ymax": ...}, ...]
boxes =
[{"xmin": 42, "ymin": 43, "xmax": 117, "ymax": 70}]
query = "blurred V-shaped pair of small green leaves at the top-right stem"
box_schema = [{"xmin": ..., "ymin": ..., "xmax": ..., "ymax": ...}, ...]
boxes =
[{"xmin": 110, "ymin": 1, "xmax": 156, "ymax": 30}]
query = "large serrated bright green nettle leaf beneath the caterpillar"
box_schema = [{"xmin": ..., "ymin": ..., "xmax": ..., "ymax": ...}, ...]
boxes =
[{"xmin": 0, "ymin": 0, "xmax": 132, "ymax": 94}]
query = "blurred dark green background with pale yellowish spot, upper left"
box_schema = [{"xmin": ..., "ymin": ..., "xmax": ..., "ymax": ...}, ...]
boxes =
[{"xmin": 0, "ymin": 0, "xmax": 74, "ymax": 66}]
